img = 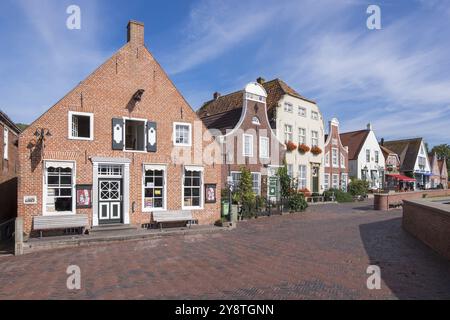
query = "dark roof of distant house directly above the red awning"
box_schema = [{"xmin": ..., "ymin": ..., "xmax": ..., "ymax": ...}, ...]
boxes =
[{"xmin": 383, "ymin": 138, "xmax": 422, "ymax": 171}]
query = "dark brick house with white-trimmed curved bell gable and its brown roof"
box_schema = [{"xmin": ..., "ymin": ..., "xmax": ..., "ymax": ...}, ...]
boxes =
[{"xmin": 197, "ymin": 82, "xmax": 285, "ymax": 197}]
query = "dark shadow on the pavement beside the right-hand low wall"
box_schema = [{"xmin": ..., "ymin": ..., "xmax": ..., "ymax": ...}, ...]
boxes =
[{"xmin": 360, "ymin": 218, "xmax": 450, "ymax": 299}]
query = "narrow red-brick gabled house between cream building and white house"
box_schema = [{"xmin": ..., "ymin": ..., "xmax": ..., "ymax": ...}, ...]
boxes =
[{"xmin": 324, "ymin": 118, "xmax": 349, "ymax": 191}]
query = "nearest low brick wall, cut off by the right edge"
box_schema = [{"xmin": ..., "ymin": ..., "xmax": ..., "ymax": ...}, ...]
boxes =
[{"xmin": 403, "ymin": 200, "xmax": 450, "ymax": 260}]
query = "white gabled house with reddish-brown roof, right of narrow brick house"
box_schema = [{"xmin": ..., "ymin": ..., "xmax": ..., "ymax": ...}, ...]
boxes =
[{"xmin": 341, "ymin": 123, "xmax": 385, "ymax": 190}]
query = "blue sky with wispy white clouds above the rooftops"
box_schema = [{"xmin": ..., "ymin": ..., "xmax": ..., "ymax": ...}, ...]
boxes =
[{"xmin": 0, "ymin": 0, "xmax": 450, "ymax": 145}]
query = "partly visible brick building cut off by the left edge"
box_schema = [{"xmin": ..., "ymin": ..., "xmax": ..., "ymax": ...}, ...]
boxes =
[{"xmin": 0, "ymin": 111, "xmax": 20, "ymax": 223}]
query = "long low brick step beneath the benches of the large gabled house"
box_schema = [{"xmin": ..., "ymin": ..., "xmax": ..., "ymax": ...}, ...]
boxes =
[{"xmin": 23, "ymin": 226, "xmax": 235, "ymax": 254}]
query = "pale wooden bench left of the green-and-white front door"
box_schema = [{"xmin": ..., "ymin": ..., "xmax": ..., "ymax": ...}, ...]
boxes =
[{"xmin": 33, "ymin": 214, "xmax": 89, "ymax": 238}]
